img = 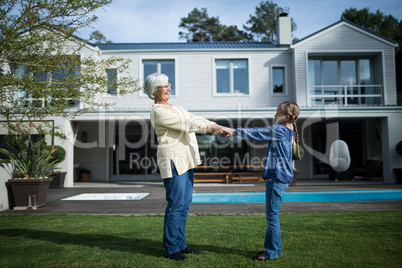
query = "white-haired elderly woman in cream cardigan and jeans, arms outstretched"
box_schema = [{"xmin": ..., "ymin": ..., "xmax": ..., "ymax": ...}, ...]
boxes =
[{"xmin": 144, "ymin": 73, "xmax": 234, "ymax": 261}]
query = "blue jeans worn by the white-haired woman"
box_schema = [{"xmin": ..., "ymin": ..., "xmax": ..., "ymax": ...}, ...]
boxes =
[{"xmin": 163, "ymin": 163, "xmax": 194, "ymax": 255}]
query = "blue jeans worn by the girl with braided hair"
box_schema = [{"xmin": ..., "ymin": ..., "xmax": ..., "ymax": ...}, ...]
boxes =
[{"xmin": 262, "ymin": 177, "xmax": 289, "ymax": 259}]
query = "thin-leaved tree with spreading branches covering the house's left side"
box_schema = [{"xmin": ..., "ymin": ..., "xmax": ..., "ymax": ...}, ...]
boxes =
[{"xmin": 0, "ymin": 0, "xmax": 138, "ymax": 137}]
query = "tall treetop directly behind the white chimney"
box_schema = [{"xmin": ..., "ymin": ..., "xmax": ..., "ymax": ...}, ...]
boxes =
[{"xmin": 243, "ymin": 1, "xmax": 297, "ymax": 41}]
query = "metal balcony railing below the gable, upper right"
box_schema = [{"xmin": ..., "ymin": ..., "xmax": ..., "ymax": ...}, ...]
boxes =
[{"xmin": 310, "ymin": 85, "xmax": 384, "ymax": 106}]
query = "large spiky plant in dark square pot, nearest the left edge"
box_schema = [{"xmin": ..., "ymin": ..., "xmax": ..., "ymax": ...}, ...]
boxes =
[{"xmin": 0, "ymin": 136, "xmax": 56, "ymax": 210}]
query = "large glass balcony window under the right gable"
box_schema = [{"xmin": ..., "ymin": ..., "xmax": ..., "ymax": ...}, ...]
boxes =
[{"xmin": 308, "ymin": 57, "xmax": 383, "ymax": 105}]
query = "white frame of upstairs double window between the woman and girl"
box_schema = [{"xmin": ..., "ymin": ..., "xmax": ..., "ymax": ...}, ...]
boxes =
[{"xmin": 212, "ymin": 56, "xmax": 251, "ymax": 97}]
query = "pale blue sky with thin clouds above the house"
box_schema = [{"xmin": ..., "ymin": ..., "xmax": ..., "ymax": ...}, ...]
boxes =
[{"xmin": 78, "ymin": 0, "xmax": 402, "ymax": 43}]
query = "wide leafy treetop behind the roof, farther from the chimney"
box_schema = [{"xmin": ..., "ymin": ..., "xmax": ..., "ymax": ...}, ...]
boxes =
[{"xmin": 179, "ymin": 8, "xmax": 250, "ymax": 42}]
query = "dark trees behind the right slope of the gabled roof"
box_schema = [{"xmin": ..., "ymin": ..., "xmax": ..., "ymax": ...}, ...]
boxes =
[{"xmin": 341, "ymin": 8, "xmax": 402, "ymax": 105}]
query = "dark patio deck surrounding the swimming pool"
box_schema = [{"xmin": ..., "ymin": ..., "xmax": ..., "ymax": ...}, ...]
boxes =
[{"xmin": 0, "ymin": 180, "xmax": 402, "ymax": 215}]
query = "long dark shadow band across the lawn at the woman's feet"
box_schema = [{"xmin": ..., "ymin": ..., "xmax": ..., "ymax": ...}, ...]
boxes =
[{"xmin": 0, "ymin": 228, "xmax": 256, "ymax": 258}]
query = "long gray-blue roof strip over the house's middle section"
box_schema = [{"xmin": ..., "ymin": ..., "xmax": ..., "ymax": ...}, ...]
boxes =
[{"xmin": 91, "ymin": 42, "xmax": 289, "ymax": 50}]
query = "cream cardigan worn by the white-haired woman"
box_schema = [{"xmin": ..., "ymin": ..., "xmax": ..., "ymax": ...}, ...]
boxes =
[{"xmin": 151, "ymin": 104, "xmax": 215, "ymax": 179}]
